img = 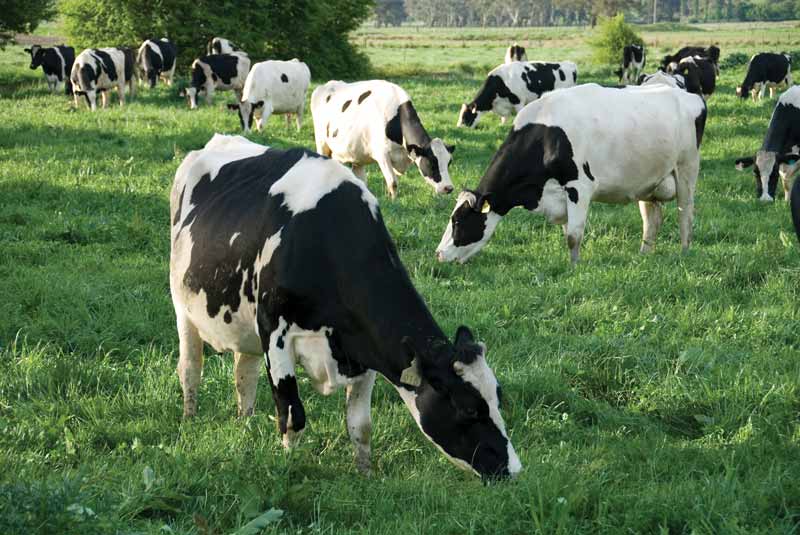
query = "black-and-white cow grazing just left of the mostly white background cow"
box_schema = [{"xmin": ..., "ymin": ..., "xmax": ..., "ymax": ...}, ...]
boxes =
[{"xmin": 181, "ymin": 52, "xmax": 250, "ymax": 109}]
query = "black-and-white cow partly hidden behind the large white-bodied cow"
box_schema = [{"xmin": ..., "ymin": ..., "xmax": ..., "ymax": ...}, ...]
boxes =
[{"xmin": 456, "ymin": 61, "xmax": 578, "ymax": 127}]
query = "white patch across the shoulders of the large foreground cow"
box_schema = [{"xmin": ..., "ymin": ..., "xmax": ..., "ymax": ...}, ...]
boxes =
[{"xmin": 269, "ymin": 155, "xmax": 378, "ymax": 219}]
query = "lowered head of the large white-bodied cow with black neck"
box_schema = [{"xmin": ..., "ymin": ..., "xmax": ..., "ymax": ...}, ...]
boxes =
[{"xmin": 436, "ymin": 191, "xmax": 501, "ymax": 264}]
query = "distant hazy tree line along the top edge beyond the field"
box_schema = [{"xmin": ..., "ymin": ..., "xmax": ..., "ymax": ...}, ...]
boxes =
[{"xmin": 375, "ymin": 0, "xmax": 800, "ymax": 27}]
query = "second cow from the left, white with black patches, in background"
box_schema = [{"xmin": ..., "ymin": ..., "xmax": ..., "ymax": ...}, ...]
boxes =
[{"xmin": 70, "ymin": 48, "xmax": 136, "ymax": 111}]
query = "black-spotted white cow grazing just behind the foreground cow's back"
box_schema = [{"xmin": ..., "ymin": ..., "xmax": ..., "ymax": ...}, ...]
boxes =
[{"xmin": 311, "ymin": 80, "xmax": 455, "ymax": 198}]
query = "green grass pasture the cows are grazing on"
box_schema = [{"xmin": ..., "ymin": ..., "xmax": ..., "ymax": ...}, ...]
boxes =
[{"xmin": 0, "ymin": 23, "xmax": 800, "ymax": 535}]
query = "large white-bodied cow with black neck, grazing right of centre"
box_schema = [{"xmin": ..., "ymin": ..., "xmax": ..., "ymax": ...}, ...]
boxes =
[{"xmin": 437, "ymin": 84, "xmax": 706, "ymax": 263}]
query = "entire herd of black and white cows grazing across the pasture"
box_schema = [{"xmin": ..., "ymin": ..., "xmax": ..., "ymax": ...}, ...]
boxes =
[{"xmin": 21, "ymin": 38, "xmax": 800, "ymax": 477}]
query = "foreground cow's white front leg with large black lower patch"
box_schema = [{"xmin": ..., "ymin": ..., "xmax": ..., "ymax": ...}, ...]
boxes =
[{"xmin": 259, "ymin": 317, "xmax": 306, "ymax": 449}]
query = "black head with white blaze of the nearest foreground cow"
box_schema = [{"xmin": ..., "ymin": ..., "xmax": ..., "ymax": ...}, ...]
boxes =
[{"xmin": 398, "ymin": 326, "xmax": 522, "ymax": 479}]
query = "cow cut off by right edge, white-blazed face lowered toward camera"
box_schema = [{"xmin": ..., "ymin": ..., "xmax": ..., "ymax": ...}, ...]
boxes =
[{"xmin": 736, "ymin": 86, "xmax": 800, "ymax": 202}]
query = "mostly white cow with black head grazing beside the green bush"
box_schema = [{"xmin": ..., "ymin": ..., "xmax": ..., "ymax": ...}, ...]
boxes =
[{"xmin": 228, "ymin": 59, "xmax": 311, "ymax": 132}]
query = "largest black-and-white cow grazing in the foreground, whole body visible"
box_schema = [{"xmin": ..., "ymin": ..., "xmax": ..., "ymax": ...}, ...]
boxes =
[{"xmin": 170, "ymin": 135, "xmax": 521, "ymax": 477}]
